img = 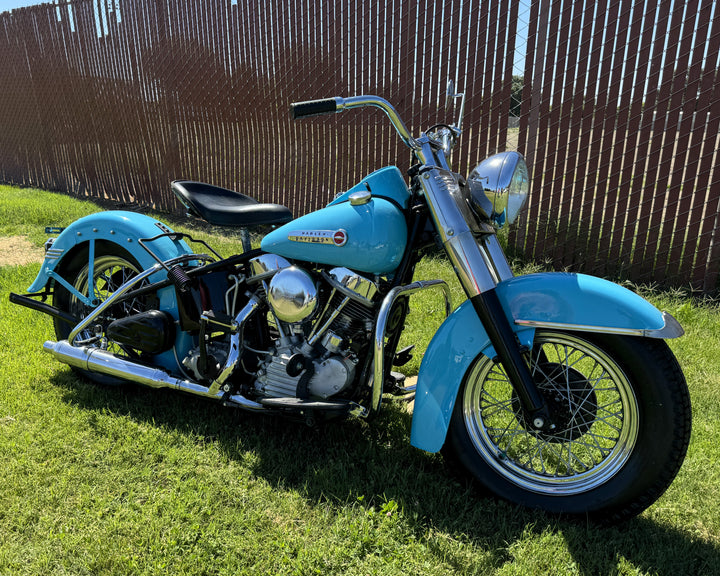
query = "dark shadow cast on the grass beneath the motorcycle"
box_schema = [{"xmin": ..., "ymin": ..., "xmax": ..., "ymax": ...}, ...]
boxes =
[{"xmin": 54, "ymin": 371, "xmax": 720, "ymax": 576}]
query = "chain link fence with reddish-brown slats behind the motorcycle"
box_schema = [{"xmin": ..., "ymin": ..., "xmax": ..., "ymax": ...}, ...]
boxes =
[{"xmin": 0, "ymin": 0, "xmax": 720, "ymax": 293}]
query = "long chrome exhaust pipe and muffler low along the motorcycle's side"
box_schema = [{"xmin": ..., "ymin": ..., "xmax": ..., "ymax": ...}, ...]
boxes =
[{"xmin": 43, "ymin": 340, "xmax": 265, "ymax": 411}]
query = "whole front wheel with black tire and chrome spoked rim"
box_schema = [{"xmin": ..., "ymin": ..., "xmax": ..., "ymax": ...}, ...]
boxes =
[{"xmin": 444, "ymin": 330, "xmax": 691, "ymax": 524}]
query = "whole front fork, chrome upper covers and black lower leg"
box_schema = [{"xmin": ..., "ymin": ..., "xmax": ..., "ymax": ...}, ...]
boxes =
[{"xmin": 419, "ymin": 168, "xmax": 554, "ymax": 430}]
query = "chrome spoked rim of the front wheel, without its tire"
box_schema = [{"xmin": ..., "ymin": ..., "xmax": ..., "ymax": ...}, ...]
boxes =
[{"xmin": 462, "ymin": 332, "xmax": 639, "ymax": 496}]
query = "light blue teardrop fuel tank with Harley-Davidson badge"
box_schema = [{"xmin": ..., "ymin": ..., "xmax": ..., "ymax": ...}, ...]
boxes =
[{"xmin": 261, "ymin": 167, "xmax": 410, "ymax": 274}]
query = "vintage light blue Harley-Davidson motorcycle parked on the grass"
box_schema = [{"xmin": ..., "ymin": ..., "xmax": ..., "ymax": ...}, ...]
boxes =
[{"xmin": 11, "ymin": 85, "xmax": 691, "ymax": 523}]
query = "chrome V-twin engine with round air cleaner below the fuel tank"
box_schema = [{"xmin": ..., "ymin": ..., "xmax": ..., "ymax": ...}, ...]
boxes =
[{"xmin": 250, "ymin": 254, "xmax": 377, "ymax": 400}]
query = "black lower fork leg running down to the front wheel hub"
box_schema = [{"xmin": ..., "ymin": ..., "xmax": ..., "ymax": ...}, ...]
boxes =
[{"xmin": 470, "ymin": 290, "xmax": 552, "ymax": 429}]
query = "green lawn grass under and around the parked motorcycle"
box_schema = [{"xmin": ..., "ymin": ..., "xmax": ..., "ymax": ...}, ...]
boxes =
[{"xmin": 0, "ymin": 187, "xmax": 720, "ymax": 576}]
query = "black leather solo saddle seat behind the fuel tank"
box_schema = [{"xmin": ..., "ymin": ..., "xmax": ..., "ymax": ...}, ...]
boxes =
[{"xmin": 170, "ymin": 180, "xmax": 293, "ymax": 228}]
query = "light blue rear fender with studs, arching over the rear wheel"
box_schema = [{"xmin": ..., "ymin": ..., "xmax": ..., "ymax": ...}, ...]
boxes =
[{"xmin": 28, "ymin": 210, "xmax": 192, "ymax": 293}]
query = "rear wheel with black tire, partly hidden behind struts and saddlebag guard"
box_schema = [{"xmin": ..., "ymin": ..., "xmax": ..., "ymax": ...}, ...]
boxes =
[{"xmin": 53, "ymin": 242, "xmax": 152, "ymax": 386}]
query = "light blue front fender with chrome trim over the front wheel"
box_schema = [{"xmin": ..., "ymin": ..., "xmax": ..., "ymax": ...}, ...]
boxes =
[{"xmin": 410, "ymin": 272, "xmax": 682, "ymax": 452}]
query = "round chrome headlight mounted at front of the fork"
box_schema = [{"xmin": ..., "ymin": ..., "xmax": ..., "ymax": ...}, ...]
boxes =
[{"xmin": 468, "ymin": 152, "xmax": 530, "ymax": 226}]
